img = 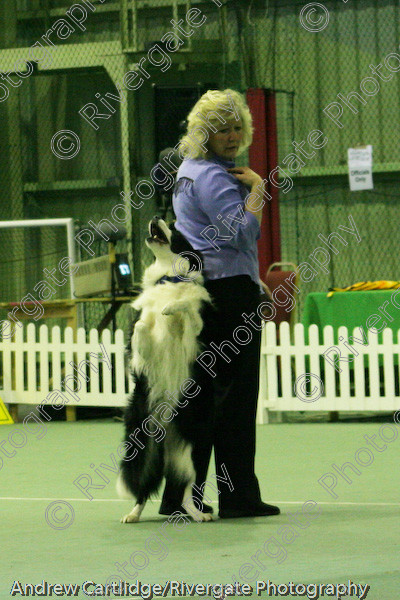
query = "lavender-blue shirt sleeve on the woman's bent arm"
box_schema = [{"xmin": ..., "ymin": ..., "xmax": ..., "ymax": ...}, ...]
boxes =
[{"xmin": 194, "ymin": 166, "xmax": 260, "ymax": 250}]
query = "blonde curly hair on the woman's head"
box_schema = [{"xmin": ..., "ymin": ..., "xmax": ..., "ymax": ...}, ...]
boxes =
[{"xmin": 178, "ymin": 88, "xmax": 253, "ymax": 158}]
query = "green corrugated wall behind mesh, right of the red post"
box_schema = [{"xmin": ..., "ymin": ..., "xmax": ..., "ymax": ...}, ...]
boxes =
[{"xmin": 231, "ymin": 0, "xmax": 400, "ymax": 314}]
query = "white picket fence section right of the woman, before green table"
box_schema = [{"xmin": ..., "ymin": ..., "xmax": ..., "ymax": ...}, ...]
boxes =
[{"xmin": 257, "ymin": 322, "xmax": 400, "ymax": 424}]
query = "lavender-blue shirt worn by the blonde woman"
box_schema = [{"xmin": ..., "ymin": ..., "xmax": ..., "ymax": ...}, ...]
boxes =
[{"xmin": 173, "ymin": 156, "xmax": 260, "ymax": 284}]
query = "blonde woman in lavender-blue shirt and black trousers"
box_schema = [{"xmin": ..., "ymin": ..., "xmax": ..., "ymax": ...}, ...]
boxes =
[{"xmin": 160, "ymin": 90, "xmax": 280, "ymax": 518}]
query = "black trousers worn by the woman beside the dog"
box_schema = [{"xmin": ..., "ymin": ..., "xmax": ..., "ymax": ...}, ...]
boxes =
[{"xmin": 163, "ymin": 275, "xmax": 261, "ymax": 509}]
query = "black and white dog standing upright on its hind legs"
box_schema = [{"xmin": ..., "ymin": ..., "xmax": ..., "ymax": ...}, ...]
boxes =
[{"xmin": 117, "ymin": 217, "xmax": 211, "ymax": 523}]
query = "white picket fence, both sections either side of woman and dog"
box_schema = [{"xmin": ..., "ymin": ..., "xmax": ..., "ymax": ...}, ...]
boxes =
[{"xmin": 0, "ymin": 322, "xmax": 400, "ymax": 423}]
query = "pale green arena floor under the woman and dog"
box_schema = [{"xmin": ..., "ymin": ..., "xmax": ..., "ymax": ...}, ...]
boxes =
[{"xmin": 0, "ymin": 418, "xmax": 400, "ymax": 600}]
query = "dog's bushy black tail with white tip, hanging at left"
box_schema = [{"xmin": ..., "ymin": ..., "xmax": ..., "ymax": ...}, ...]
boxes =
[{"xmin": 117, "ymin": 375, "xmax": 163, "ymax": 502}]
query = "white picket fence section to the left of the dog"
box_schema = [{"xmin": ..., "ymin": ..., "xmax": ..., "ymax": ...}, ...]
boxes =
[{"xmin": 0, "ymin": 323, "xmax": 133, "ymax": 406}]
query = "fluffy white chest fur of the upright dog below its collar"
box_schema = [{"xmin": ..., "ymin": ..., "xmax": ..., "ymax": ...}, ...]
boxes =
[{"xmin": 132, "ymin": 278, "xmax": 211, "ymax": 405}]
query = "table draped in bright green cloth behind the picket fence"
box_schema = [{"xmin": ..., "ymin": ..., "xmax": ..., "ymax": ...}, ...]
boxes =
[{"xmin": 301, "ymin": 289, "xmax": 400, "ymax": 344}]
